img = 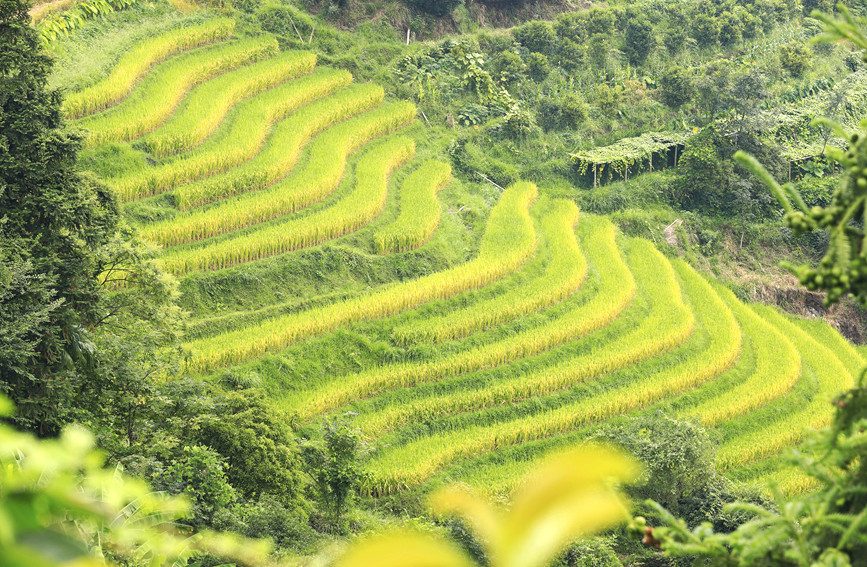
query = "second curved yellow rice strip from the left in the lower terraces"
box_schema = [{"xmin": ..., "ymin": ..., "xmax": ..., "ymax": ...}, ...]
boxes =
[{"xmin": 391, "ymin": 200, "xmax": 587, "ymax": 345}]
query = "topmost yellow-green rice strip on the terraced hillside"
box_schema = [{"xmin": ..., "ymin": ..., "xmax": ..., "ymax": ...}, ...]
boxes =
[{"xmin": 63, "ymin": 18, "xmax": 235, "ymax": 119}]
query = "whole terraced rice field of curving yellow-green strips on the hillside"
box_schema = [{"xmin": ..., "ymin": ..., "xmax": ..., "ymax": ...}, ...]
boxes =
[{"xmin": 65, "ymin": 19, "xmax": 865, "ymax": 495}]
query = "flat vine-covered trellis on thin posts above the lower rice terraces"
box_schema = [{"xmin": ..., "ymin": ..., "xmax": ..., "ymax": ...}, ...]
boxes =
[{"xmin": 570, "ymin": 132, "xmax": 693, "ymax": 187}]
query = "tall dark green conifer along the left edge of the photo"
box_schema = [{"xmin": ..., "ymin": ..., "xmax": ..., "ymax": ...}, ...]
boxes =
[{"xmin": 0, "ymin": 0, "xmax": 119, "ymax": 435}]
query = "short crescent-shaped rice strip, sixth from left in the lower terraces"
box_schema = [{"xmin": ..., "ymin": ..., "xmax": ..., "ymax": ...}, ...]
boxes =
[{"xmin": 689, "ymin": 289, "xmax": 801, "ymax": 425}]
